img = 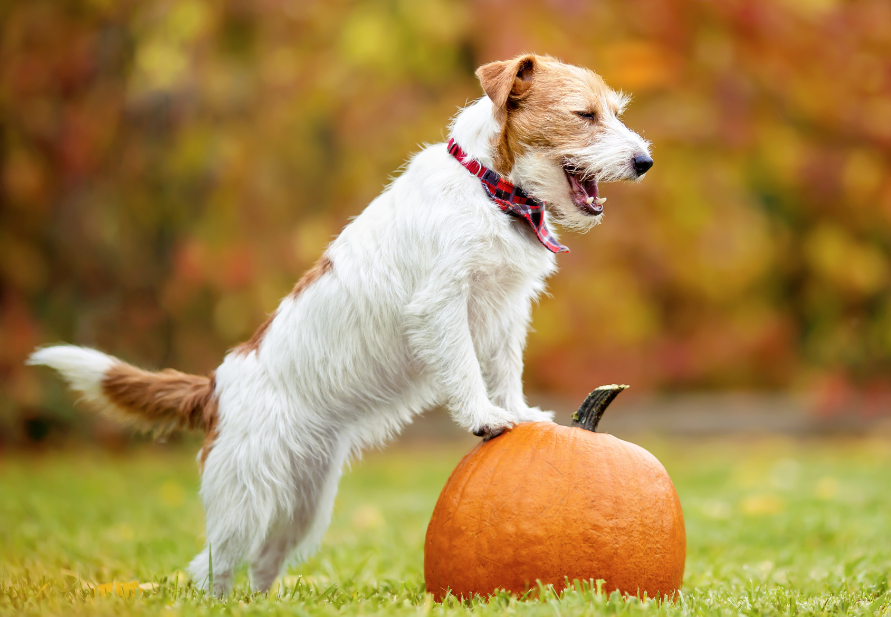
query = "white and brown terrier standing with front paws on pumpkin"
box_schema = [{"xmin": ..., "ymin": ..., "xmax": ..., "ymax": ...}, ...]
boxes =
[{"xmin": 28, "ymin": 54, "xmax": 653, "ymax": 594}]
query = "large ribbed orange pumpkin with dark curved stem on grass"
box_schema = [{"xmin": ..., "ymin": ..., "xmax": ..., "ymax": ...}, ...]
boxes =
[{"xmin": 424, "ymin": 386, "xmax": 687, "ymax": 601}]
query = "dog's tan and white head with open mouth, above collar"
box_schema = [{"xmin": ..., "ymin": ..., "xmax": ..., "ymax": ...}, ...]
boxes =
[{"xmin": 476, "ymin": 54, "xmax": 653, "ymax": 230}]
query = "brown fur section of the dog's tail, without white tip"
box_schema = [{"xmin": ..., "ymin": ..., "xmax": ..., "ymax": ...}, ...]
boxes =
[{"xmin": 102, "ymin": 363, "xmax": 216, "ymax": 432}]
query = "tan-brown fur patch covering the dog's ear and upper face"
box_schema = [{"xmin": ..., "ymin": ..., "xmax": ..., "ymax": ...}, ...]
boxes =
[{"xmin": 476, "ymin": 54, "xmax": 616, "ymax": 176}]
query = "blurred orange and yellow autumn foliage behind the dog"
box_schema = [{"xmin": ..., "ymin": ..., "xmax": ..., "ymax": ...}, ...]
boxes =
[{"xmin": 0, "ymin": 0, "xmax": 891, "ymax": 443}]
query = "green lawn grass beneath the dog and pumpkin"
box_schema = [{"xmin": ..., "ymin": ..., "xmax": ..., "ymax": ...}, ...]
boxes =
[{"xmin": 0, "ymin": 440, "xmax": 891, "ymax": 617}]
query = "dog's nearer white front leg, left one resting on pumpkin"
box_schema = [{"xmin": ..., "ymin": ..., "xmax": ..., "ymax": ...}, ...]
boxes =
[{"xmin": 405, "ymin": 276, "xmax": 516, "ymax": 439}]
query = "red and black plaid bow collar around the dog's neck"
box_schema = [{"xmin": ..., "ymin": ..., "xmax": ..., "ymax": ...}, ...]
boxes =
[{"xmin": 449, "ymin": 139, "xmax": 569, "ymax": 253}]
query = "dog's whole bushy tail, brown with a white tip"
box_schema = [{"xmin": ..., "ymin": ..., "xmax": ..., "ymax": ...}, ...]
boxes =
[{"xmin": 27, "ymin": 345, "xmax": 216, "ymax": 433}]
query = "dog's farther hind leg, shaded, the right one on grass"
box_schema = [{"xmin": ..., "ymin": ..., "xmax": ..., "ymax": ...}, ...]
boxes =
[{"xmin": 250, "ymin": 439, "xmax": 349, "ymax": 591}]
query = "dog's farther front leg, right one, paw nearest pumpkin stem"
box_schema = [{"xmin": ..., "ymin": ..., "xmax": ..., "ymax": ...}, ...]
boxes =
[{"xmin": 484, "ymin": 299, "xmax": 554, "ymax": 422}]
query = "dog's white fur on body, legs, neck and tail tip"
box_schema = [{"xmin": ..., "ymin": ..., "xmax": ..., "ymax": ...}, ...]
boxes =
[{"xmin": 32, "ymin": 90, "xmax": 640, "ymax": 592}]
